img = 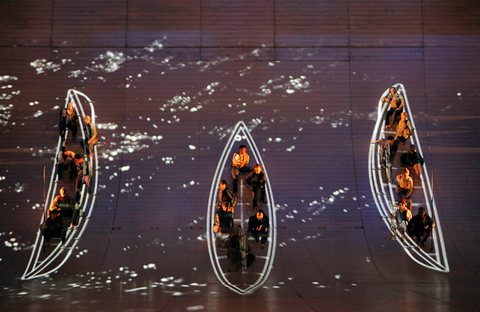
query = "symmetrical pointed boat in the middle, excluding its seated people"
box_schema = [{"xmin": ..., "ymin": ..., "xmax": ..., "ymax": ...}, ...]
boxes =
[{"xmin": 206, "ymin": 121, "xmax": 277, "ymax": 295}]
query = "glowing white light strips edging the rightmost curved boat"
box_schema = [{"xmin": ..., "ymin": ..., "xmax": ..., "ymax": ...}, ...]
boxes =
[{"xmin": 368, "ymin": 83, "xmax": 450, "ymax": 272}]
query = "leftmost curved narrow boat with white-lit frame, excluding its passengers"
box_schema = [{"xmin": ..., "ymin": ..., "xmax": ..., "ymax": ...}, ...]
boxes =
[{"xmin": 21, "ymin": 89, "xmax": 98, "ymax": 280}]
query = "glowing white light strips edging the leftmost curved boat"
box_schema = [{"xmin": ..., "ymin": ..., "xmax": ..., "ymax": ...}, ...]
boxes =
[{"xmin": 21, "ymin": 89, "xmax": 98, "ymax": 280}]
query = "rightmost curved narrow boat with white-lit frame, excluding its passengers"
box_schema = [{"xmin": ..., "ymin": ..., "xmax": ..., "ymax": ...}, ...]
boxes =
[{"xmin": 368, "ymin": 83, "xmax": 450, "ymax": 272}]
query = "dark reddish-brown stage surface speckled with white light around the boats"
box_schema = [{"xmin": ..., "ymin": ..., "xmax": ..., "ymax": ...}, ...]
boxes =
[{"xmin": 0, "ymin": 0, "xmax": 480, "ymax": 312}]
